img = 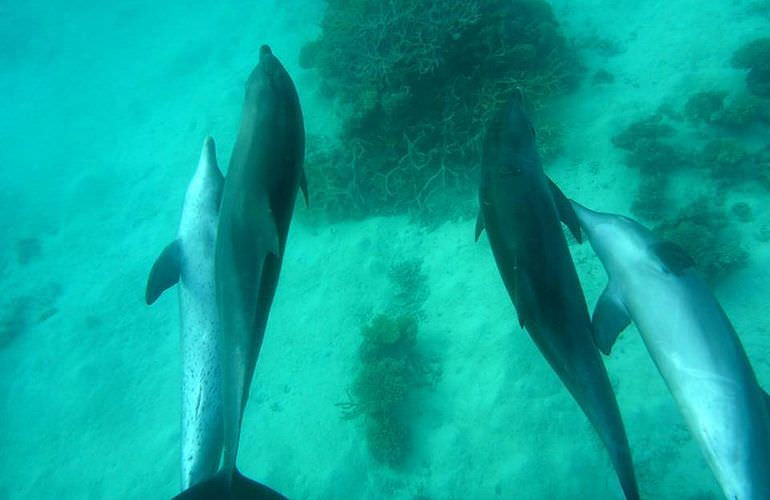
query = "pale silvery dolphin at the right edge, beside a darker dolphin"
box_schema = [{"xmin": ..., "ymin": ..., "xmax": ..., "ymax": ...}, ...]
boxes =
[{"xmin": 572, "ymin": 201, "xmax": 770, "ymax": 500}]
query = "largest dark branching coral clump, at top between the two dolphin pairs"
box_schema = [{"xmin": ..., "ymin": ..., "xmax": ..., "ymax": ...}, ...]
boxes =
[{"xmin": 301, "ymin": 0, "xmax": 579, "ymax": 217}]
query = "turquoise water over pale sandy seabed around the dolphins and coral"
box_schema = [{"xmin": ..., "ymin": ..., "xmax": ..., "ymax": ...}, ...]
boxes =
[{"xmin": 0, "ymin": 0, "xmax": 770, "ymax": 499}]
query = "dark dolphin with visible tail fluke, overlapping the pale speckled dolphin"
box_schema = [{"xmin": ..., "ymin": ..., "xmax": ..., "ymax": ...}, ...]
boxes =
[{"xmin": 172, "ymin": 45, "xmax": 307, "ymax": 499}]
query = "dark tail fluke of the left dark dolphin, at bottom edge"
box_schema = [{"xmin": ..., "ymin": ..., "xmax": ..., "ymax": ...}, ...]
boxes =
[{"xmin": 174, "ymin": 469, "xmax": 286, "ymax": 500}]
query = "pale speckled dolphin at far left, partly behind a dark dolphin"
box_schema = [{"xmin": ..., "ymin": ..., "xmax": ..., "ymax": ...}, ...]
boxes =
[{"xmin": 145, "ymin": 137, "xmax": 223, "ymax": 489}]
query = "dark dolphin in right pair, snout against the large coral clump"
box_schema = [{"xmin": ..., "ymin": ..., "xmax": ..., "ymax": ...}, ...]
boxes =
[{"xmin": 476, "ymin": 91, "xmax": 639, "ymax": 499}]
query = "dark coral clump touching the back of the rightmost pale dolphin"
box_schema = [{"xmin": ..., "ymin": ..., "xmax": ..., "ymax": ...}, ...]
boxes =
[{"xmin": 655, "ymin": 198, "xmax": 748, "ymax": 285}]
